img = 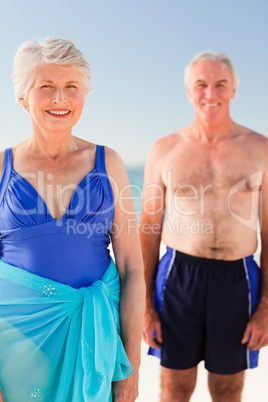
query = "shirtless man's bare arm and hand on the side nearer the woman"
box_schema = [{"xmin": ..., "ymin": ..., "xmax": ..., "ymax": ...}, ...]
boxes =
[{"xmin": 140, "ymin": 143, "xmax": 165, "ymax": 349}]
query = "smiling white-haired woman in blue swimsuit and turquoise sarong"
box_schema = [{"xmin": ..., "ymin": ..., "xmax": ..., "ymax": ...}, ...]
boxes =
[{"xmin": 0, "ymin": 37, "xmax": 144, "ymax": 402}]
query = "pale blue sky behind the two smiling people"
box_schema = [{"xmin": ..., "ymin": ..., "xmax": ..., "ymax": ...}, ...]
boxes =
[{"xmin": 0, "ymin": 0, "xmax": 268, "ymax": 166}]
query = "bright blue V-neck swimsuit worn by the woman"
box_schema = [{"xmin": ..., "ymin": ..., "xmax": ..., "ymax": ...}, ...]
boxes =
[{"xmin": 0, "ymin": 145, "xmax": 114, "ymax": 288}]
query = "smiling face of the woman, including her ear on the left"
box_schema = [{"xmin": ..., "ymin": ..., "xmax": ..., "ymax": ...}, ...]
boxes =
[{"xmin": 22, "ymin": 64, "xmax": 85, "ymax": 132}]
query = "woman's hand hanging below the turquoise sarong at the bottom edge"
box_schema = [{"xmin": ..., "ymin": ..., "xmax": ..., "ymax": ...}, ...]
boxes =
[{"xmin": 112, "ymin": 370, "xmax": 139, "ymax": 402}]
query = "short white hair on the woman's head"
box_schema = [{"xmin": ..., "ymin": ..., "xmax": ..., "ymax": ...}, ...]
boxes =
[{"xmin": 12, "ymin": 36, "xmax": 92, "ymax": 100}]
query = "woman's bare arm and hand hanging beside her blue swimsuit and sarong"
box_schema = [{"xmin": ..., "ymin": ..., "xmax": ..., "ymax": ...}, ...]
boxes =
[{"xmin": 105, "ymin": 148, "xmax": 145, "ymax": 402}]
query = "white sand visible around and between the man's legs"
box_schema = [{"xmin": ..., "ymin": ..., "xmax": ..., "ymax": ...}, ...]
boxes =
[{"xmin": 137, "ymin": 343, "xmax": 268, "ymax": 402}]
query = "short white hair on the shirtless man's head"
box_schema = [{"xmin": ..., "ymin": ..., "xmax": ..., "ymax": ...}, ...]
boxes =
[{"xmin": 184, "ymin": 50, "xmax": 239, "ymax": 87}]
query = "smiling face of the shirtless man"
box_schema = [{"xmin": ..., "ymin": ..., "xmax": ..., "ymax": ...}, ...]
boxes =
[{"xmin": 187, "ymin": 61, "xmax": 235, "ymax": 122}]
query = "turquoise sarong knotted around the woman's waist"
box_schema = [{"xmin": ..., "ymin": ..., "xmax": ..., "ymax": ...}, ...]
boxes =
[{"xmin": 0, "ymin": 260, "xmax": 132, "ymax": 402}]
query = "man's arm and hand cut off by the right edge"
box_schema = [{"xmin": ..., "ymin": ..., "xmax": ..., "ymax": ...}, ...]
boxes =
[{"xmin": 242, "ymin": 141, "xmax": 268, "ymax": 350}]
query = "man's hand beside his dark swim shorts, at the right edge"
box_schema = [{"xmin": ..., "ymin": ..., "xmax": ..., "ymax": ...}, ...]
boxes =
[{"xmin": 241, "ymin": 301, "xmax": 268, "ymax": 350}]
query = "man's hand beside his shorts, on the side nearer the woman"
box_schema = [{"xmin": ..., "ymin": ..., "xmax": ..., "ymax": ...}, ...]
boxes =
[{"xmin": 143, "ymin": 308, "xmax": 163, "ymax": 349}]
